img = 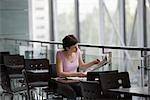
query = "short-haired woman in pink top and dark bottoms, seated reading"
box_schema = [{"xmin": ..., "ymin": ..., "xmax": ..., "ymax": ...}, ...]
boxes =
[{"xmin": 56, "ymin": 35, "xmax": 104, "ymax": 99}]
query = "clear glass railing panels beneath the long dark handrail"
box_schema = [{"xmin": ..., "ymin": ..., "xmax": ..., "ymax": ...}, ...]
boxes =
[{"xmin": 0, "ymin": 38, "xmax": 150, "ymax": 86}]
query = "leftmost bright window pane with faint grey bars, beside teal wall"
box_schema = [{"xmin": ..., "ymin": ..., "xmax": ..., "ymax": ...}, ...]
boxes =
[{"xmin": 30, "ymin": 0, "xmax": 50, "ymax": 41}]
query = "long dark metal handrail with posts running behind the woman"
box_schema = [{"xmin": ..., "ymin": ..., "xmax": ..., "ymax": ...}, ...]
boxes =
[{"xmin": 0, "ymin": 38, "xmax": 150, "ymax": 86}]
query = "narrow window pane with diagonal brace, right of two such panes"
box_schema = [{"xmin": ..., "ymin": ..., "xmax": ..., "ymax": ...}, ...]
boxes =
[{"xmin": 125, "ymin": 0, "xmax": 138, "ymax": 46}]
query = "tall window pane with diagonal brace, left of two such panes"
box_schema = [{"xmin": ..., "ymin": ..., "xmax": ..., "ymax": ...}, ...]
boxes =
[{"xmin": 103, "ymin": 0, "xmax": 119, "ymax": 45}]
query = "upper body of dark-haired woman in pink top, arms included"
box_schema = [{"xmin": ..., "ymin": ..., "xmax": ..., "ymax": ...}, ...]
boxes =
[{"xmin": 56, "ymin": 35, "xmax": 100, "ymax": 77}]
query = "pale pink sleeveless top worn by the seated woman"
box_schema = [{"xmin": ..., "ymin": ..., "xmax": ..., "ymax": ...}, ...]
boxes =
[{"xmin": 57, "ymin": 49, "xmax": 80, "ymax": 72}]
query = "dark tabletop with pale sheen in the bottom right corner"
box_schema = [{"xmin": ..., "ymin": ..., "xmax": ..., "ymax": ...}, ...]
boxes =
[{"xmin": 108, "ymin": 87, "xmax": 150, "ymax": 98}]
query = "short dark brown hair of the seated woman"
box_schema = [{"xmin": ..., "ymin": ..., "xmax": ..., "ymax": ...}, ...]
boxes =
[{"xmin": 62, "ymin": 35, "xmax": 78, "ymax": 51}]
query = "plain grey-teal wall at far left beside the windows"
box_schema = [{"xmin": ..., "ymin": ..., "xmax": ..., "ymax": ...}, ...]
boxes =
[{"xmin": 0, "ymin": 0, "xmax": 29, "ymax": 51}]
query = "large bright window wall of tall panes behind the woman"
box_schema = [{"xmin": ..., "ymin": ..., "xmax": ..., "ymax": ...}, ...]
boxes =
[{"xmin": 28, "ymin": 0, "xmax": 150, "ymax": 85}]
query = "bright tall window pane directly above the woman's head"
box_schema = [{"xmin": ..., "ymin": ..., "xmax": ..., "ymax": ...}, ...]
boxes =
[{"xmin": 56, "ymin": 0, "xmax": 75, "ymax": 41}]
